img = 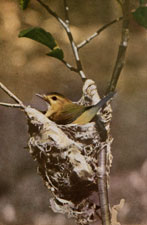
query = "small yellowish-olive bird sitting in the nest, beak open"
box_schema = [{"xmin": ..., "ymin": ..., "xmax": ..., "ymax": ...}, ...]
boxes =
[{"xmin": 36, "ymin": 92, "xmax": 115, "ymax": 125}]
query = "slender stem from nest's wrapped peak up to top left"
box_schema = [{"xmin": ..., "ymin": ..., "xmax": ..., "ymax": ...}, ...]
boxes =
[{"xmin": 36, "ymin": 0, "xmax": 86, "ymax": 81}]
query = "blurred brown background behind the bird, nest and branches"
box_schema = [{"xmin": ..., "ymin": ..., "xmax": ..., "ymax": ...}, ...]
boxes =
[{"xmin": 0, "ymin": 0, "xmax": 147, "ymax": 225}]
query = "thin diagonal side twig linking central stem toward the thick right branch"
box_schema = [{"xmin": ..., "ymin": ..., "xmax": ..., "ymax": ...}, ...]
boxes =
[{"xmin": 77, "ymin": 16, "xmax": 123, "ymax": 50}]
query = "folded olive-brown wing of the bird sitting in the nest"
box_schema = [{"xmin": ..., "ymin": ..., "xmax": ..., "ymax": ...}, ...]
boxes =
[{"xmin": 56, "ymin": 103, "xmax": 85, "ymax": 124}]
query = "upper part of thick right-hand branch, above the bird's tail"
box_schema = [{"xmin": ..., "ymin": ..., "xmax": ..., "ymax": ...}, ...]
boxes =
[{"xmin": 106, "ymin": 0, "xmax": 129, "ymax": 93}]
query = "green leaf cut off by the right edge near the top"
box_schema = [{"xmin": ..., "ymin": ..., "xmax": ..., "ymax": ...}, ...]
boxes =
[{"xmin": 133, "ymin": 6, "xmax": 147, "ymax": 28}]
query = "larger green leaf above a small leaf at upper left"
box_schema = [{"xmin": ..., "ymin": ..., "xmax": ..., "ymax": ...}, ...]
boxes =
[{"xmin": 18, "ymin": 27, "xmax": 57, "ymax": 50}]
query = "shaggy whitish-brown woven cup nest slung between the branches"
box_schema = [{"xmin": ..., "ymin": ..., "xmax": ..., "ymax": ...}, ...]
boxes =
[{"xmin": 25, "ymin": 80, "xmax": 112, "ymax": 224}]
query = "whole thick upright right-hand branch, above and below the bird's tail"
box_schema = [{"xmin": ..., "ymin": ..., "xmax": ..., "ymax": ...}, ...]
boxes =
[{"xmin": 98, "ymin": 0, "xmax": 129, "ymax": 225}]
